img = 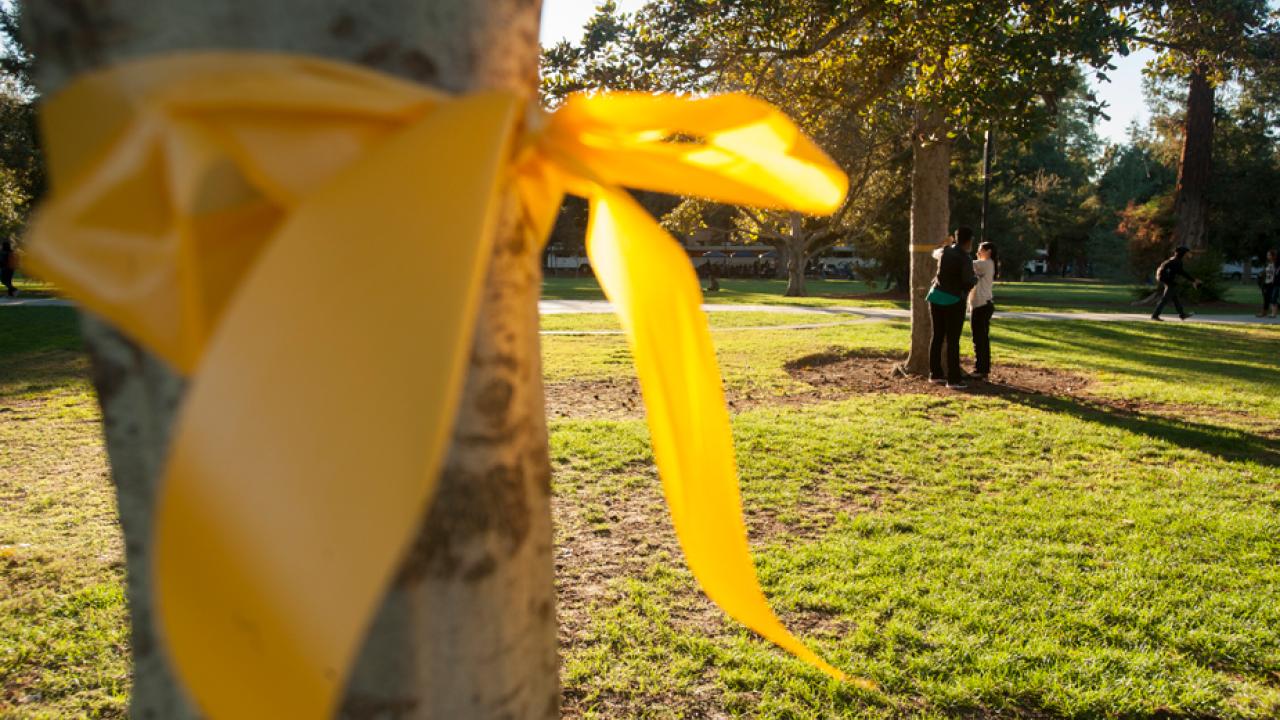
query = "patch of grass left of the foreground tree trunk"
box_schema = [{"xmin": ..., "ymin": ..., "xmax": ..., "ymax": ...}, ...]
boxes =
[{"xmin": 0, "ymin": 307, "xmax": 129, "ymax": 719}]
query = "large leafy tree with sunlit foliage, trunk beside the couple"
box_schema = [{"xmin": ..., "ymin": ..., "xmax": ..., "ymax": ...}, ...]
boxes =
[{"xmin": 544, "ymin": 0, "xmax": 1126, "ymax": 373}]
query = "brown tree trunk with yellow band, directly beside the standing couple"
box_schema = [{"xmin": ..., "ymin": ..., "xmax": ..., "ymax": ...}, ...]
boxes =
[{"xmin": 905, "ymin": 109, "xmax": 951, "ymax": 375}]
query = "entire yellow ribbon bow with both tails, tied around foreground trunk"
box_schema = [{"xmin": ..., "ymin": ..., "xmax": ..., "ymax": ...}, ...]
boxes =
[{"xmin": 29, "ymin": 53, "xmax": 846, "ymax": 719}]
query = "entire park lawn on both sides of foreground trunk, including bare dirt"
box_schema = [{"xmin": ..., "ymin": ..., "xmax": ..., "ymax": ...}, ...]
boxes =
[{"xmin": 0, "ymin": 303, "xmax": 1280, "ymax": 719}]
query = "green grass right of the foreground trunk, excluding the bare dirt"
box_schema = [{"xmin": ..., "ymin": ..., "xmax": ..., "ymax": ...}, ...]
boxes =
[{"xmin": 544, "ymin": 316, "xmax": 1280, "ymax": 717}]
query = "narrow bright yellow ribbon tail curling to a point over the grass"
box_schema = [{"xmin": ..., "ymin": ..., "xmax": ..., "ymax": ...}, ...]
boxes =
[{"xmin": 586, "ymin": 187, "xmax": 844, "ymax": 679}]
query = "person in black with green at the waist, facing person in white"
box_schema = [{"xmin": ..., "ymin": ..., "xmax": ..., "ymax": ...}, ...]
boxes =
[{"xmin": 925, "ymin": 227, "xmax": 977, "ymax": 389}]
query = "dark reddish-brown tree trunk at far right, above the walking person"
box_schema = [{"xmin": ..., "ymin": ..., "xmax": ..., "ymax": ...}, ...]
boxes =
[{"xmin": 1174, "ymin": 64, "xmax": 1213, "ymax": 250}]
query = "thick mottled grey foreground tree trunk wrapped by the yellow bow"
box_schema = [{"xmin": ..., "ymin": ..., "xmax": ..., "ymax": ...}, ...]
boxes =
[{"xmin": 24, "ymin": 0, "xmax": 559, "ymax": 719}]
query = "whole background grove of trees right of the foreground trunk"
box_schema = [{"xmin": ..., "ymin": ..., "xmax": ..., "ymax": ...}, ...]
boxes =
[{"xmin": 543, "ymin": 0, "xmax": 1280, "ymax": 363}]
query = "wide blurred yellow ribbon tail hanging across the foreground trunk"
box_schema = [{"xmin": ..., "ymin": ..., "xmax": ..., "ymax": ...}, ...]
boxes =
[{"xmin": 155, "ymin": 95, "xmax": 520, "ymax": 719}]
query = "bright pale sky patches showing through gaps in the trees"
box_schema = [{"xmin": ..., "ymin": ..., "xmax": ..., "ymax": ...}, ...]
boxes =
[{"xmin": 541, "ymin": 0, "xmax": 1152, "ymax": 143}]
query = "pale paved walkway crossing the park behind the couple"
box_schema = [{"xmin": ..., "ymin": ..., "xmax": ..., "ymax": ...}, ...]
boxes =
[{"xmin": 10, "ymin": 296, "xmax": 1280, "ymax": 326}]
